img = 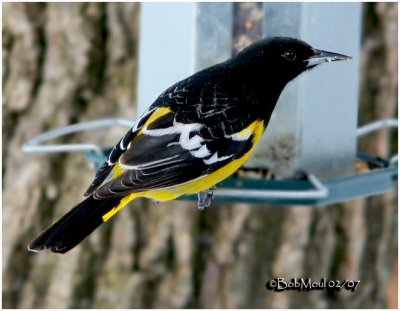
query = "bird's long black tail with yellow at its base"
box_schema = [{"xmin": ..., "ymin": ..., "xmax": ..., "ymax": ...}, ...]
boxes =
[{"xmin": 28, "ymin": 195, "xmax": 135, "ymax": 254}]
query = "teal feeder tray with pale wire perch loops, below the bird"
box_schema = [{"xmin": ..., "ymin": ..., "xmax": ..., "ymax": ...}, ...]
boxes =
[{"xmin": 22, "ymin": 119, "xmax": 398, "ymax": 206}]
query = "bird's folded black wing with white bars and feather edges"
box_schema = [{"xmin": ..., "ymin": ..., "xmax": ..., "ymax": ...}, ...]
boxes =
[{"xmin": 94, "ymin": 108, "xmax": 252, "ymax": 199}]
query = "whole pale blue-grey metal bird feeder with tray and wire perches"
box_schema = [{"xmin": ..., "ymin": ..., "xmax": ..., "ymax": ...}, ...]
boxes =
[{"xmin": 22, "ymin": 3, "xmax": 398, "ymax": 206}]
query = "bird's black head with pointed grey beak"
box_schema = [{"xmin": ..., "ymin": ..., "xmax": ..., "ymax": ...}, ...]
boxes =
[{"xmin": 236, "ymin": 37, "xmax": 351, "ymax": 88}]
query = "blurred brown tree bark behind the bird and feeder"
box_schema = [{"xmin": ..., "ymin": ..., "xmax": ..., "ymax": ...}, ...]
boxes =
[{"xmin": 2, "ymin": 2, "xmax": 398, "ymax": 308}]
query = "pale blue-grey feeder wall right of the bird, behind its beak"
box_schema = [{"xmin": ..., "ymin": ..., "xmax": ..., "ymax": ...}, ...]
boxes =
[{"xmin": 247, "ymin": 2, "xmax": 361, "ymax": 179}]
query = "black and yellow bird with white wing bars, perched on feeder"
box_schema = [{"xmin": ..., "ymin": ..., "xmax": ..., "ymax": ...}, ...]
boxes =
[{"xmin": 28, "ymin": 37, "xmax": 351, "ymax": 254}]
